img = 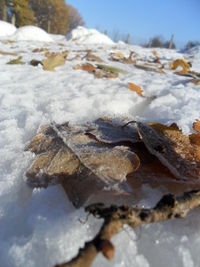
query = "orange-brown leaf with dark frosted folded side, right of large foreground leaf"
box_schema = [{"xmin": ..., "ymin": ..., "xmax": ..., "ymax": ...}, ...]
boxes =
[{"xmin": 137, "ymin": 122, "xmax": 200, "ymax": 183}]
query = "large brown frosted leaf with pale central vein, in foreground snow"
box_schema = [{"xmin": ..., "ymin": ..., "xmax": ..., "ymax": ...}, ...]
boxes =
[{"xmin": 26, "ymin": 120, "xmax": 140, "ymax": 207}]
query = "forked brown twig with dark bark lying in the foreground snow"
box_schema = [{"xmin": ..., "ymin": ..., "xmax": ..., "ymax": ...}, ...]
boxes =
[{"xmin": 56, "ymin": 190, "xmax": 200, "ymax": 267}]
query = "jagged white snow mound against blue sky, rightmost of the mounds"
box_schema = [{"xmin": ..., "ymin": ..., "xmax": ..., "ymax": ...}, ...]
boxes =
[{"xmin": 67, "ymin": 26, "xmax": 114, "ymax": 45}]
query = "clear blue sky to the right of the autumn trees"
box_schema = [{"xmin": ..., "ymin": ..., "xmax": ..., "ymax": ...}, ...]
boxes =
[{"xmin": 66, "ymin": 0, "xmax": 200, "ymax": 46}]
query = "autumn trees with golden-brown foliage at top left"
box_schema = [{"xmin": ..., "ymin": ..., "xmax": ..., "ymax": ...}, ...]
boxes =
[{"xmin": 0, "ymin": 0, "xmax": 84, "ymax": 35}]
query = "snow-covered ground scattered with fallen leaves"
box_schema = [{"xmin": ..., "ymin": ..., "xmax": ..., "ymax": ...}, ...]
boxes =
[{"xmin": 0, "ymin": 24, "xmax": 200, "ymax": 267}]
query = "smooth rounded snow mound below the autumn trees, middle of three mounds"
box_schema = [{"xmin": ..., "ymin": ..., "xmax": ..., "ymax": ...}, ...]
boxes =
[{"xmin": 12, "ymin": 26, "xmax": 53, "ymax": 42}]
